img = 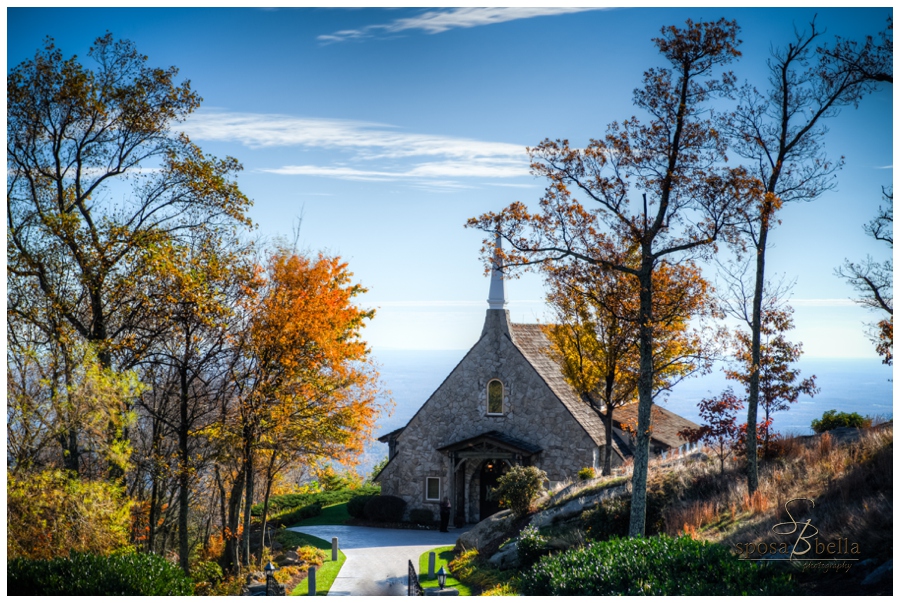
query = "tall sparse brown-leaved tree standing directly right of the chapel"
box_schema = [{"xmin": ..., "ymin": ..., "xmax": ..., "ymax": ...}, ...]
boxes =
[{"xmin": 468, "ymin": 19, "xmax": 744, "ymax": 536}]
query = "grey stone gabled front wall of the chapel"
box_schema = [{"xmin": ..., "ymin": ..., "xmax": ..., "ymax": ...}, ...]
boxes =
[{"xmin": 378, "ymin": 310, "xmax": 597, "ymax": 521}]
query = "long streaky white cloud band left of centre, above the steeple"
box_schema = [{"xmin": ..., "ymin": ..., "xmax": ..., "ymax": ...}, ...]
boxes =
[{"xmin": 185, "ymin": 111, "xmax": 529, "ymax": 188}]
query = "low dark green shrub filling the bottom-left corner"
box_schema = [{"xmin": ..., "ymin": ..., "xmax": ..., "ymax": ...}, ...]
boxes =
[{"xmin": 6, "ymin": 552, "xmax": 194, "ymax": 596}]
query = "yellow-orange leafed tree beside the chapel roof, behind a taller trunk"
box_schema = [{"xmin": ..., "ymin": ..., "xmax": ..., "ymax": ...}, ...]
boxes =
[{"xmin": 545, "ymin": 255, "xmax": 714, "ymax": 475}]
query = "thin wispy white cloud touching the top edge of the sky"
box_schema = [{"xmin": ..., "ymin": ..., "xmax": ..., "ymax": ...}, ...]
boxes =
[{"xmin": 317, "ymin": 7, "xmax": 600, "ymax": 43}]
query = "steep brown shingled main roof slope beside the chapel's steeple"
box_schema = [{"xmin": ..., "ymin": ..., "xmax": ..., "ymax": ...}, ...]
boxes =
[{"xmin": 510, "ymin": 324, "xmax": 621, "ymax": 454}]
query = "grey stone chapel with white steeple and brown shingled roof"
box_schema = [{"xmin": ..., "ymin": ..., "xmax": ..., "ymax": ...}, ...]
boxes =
[{"xmin": 376, "ymin": 241, "xmax": 697, "ymax": 523}]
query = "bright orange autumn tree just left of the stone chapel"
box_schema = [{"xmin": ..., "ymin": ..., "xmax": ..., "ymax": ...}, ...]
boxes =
[{"xmin": 230, "ymin": 250, "xmax": 383, "ymax": 564}]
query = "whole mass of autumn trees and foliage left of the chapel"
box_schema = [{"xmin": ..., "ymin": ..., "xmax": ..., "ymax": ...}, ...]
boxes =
[{"xmin": 7, "ymin": 34, "xmax": 382, "ymax": 572}]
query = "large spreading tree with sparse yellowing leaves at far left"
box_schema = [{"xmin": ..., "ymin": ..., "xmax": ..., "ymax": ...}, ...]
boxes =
[{"xmin": 6, "ymin": 34, "xmax": 249, "ymax": 368}]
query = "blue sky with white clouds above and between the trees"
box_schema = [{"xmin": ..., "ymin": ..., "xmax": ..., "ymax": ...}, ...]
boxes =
[{"xmin": 7, "ymin": 8, "xmax": 893, "ymax": 358}]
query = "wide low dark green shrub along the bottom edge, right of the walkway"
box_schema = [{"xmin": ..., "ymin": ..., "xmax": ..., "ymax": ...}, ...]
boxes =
[{"xmin": 519, "ymin": 536, "xmax": 796, "ymax": 596}]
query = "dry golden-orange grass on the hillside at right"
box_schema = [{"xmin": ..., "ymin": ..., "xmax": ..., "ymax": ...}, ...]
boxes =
[{"xmin": 651, "ymin": 425, "xmax": 893, "ymax": 558}]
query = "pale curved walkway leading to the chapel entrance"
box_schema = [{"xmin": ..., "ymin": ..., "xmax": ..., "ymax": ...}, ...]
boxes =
[{"xmin": 290, "ymin": 526, "xmax": 465, "ymax": 596}]
